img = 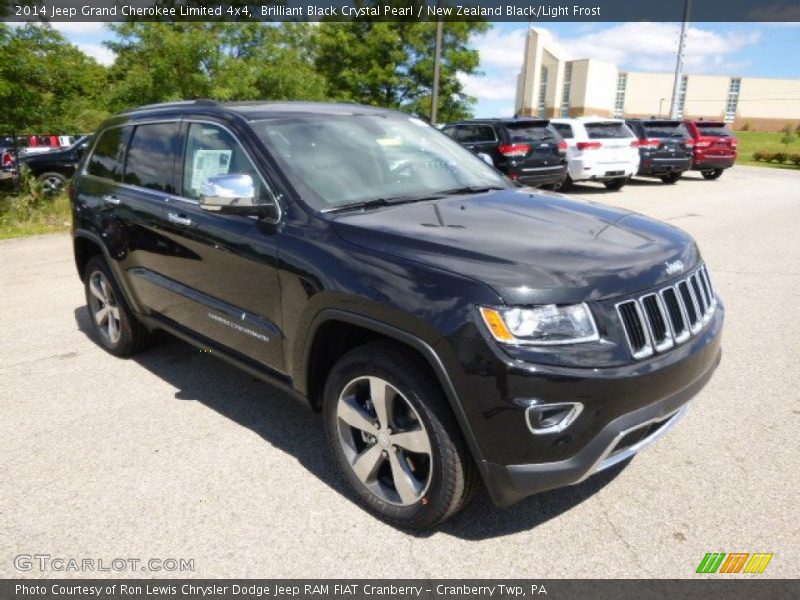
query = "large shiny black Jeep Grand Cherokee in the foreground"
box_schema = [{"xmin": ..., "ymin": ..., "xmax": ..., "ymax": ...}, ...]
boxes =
[{"xmin": 71, "ymin": 101, "xmax": 723, "ymax": 528}]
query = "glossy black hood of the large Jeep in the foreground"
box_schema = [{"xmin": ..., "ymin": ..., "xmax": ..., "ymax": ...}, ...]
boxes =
[{"xmin": 333, "ymin": 190, "xmax": 699, "ymax": 305}]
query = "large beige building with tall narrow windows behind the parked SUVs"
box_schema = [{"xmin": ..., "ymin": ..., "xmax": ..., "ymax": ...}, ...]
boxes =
[{"xmin": 516, "ymin": 27, "xmax": 800, "ymax": 131}]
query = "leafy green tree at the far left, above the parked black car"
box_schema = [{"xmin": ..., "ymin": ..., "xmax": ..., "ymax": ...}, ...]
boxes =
[{"xmin": 0, "ymin": 24, "xmax": 107, "ymax": 133}]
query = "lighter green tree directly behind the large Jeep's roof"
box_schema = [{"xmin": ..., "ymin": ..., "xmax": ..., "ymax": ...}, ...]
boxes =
[{"xmin": 107, "ymin": 22, "xmax": 326, "ymax": 110}]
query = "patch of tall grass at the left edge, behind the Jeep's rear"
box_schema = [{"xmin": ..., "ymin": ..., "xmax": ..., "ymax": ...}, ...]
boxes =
[{"xmin": 0, "ymin": 194, "xmax": 72, "ymax": 240}]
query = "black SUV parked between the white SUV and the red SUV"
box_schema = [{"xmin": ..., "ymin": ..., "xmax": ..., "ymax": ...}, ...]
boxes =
[{"xmin": 625, "ymin": 119, "xmax": 693, "ymax": 183}]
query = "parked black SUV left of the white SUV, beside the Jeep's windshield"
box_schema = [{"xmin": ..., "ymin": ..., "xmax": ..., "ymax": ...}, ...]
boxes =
[{"xmin": 442, "ymin": 119, "xmax": 567, "ymax": 189}]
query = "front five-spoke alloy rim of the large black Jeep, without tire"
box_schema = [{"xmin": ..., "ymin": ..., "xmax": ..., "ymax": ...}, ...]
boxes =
[{"xmin": 336, "ymin": 377, "xmax": 432, "ymax": 506}]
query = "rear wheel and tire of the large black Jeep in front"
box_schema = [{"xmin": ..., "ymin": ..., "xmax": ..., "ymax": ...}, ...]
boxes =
[{"xmin": 83, "ymin": 255, "xmax": 150, "ymax": 356}]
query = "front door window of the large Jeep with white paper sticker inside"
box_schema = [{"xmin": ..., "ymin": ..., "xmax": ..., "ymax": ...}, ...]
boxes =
[{"xmin": 182, "ymin": 123, "xmax": 272, "ymax": 204}]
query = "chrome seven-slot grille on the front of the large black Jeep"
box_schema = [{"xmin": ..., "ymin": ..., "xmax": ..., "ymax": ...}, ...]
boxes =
[{"xmin": 617, "ymin": 265, "xmax": 717, "ymax": 359}]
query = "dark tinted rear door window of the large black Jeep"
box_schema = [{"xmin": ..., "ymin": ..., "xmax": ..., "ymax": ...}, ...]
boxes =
[{"xmin": 122, "ymin": 123, "xmax": 180, "ymax": 194}]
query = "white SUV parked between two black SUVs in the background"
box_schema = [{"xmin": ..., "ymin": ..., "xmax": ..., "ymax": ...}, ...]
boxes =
[{"xmin": 550, "ymin": 117, "xmax": 639, "ymax": 190}]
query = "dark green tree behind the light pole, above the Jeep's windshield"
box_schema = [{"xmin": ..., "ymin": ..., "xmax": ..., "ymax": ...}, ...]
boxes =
[{"xmin": 315, "ymin": 21, "xmax": 488, "ymax": 121}]
